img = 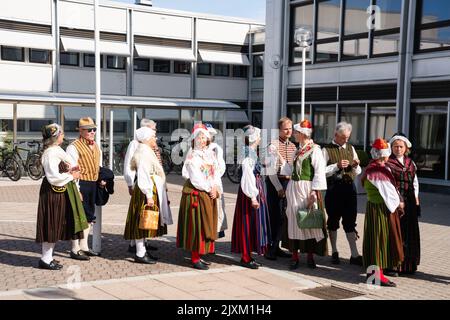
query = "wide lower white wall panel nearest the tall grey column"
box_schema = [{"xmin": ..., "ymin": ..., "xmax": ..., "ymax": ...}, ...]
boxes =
[{"xmin": 197, "ymin": 78, "xmax": 248, "ymax": 100}]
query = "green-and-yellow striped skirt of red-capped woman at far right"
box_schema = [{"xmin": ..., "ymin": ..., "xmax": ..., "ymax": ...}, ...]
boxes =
[{"xmin": 363, "ymin": 201, "xmax": 403, "ymax": 269}]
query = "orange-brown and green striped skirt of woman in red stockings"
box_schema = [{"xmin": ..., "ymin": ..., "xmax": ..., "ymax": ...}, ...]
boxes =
[{"xmin": 177, "ymin": 180, "xmax": 218, "ymax": 255}]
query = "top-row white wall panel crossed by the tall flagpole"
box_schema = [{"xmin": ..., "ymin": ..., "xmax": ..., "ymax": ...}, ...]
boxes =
[{"xmin": 59, "ymin": 1, "xmax": 127, "ymax": 33}]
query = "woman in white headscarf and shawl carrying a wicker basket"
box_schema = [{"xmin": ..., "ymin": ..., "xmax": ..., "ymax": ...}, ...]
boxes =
[{"xmin": 124, "ymin": 127, "xmax": 173, "ymax": 264}]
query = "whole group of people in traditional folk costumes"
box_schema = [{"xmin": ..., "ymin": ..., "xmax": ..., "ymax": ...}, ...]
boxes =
[{"xmin": 36, "ymin": 118, "xmax": 420, "ymax": 286}]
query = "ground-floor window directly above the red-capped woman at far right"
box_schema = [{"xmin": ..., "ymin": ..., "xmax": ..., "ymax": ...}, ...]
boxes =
[{"xmin": 368, "ymin": 106, "xmax": 397, "ymax": 146}]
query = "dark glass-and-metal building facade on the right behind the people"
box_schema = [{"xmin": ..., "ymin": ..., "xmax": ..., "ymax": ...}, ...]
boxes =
[{"xmin": 264, "ymin": 0, "xmax": 450, "ymax": 190}]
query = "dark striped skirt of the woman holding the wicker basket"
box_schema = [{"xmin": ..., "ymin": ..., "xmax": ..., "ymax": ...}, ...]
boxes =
[{"xmin": 123, "ymin": 184, "xmax": 167, "ymax": 240}]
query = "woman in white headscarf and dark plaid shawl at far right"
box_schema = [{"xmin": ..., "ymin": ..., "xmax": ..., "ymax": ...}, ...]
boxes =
[{"xmin": 386, "ymin": 133, "xmax": 420, "ymax": 274}]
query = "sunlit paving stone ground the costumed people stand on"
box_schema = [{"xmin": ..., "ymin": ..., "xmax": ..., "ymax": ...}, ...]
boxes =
[{"xmin": 0, "ymin": 175, "xmax": 450, "ymax": 300}]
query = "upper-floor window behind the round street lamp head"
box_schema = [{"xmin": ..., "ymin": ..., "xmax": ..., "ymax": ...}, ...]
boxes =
[{"xmin": 290, "ymin": 4, "xmax": 314, "ymax": 64}]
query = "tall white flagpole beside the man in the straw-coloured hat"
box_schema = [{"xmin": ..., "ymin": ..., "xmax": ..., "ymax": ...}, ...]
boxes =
[{"xmin": 92, "ymin": 0, "xmax": 102, "ymax": 253}]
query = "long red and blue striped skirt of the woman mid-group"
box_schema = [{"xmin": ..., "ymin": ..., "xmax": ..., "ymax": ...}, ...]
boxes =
[{"xmin": 231, "ymin": 175, "xmax": 271, "ymax": 255}]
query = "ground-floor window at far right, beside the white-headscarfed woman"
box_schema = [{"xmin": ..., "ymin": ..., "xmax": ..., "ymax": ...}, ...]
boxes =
[{"xmin": 411, "ymin": 105, "xmax": 448, "ymax": 179}]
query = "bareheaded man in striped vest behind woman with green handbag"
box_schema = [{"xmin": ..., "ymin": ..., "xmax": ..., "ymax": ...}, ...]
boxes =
[{"xmin": 264, "ymin": 118, "xmax": 297, "ymax": 260}]
